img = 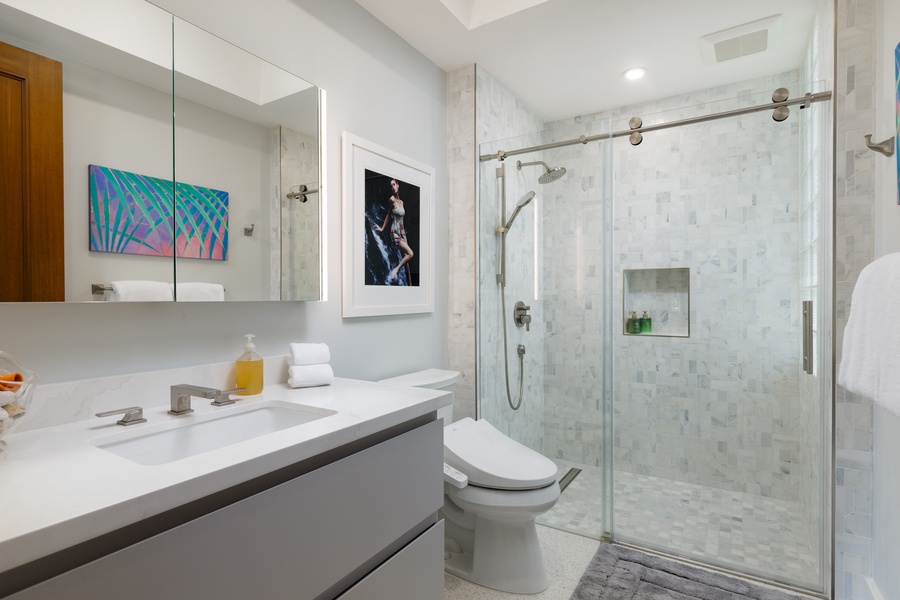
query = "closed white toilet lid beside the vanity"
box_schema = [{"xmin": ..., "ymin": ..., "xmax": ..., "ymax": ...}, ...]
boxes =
[{"xmin": 444, "ymin": 417, "xmax": 557, "ymax": 490}]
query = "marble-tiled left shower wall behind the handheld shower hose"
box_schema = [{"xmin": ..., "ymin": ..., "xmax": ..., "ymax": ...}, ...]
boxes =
[{"xmin": 475, "ymin": 67, "xmax": 545, "ymax": 452}]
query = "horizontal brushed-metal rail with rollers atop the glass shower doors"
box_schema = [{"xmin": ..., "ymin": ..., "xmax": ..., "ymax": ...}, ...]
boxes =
[{"xmin": 479, "ymin": 88, "xmax": 831, "ymax": 162}]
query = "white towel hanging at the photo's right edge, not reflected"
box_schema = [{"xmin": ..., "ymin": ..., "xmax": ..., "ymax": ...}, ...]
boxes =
[{"xmin": 838, "ymin": 253, "xmax": 900, "ymax": 417}]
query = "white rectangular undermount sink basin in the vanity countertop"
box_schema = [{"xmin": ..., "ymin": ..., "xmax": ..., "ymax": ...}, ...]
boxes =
[{"xmin": 91, "ymin": 402, "xmax": 337, "ymax": 465}]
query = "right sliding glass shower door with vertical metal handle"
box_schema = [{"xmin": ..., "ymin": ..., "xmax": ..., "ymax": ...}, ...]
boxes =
[{"xmin": 612, "ymin": 86, "xmax": 831, "ymax": 591}]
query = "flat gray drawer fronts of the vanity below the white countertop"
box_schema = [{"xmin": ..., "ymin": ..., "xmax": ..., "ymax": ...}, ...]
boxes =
[{"xmin": 9, "ymin": 421, "xmax": 444, "ymax": 600}]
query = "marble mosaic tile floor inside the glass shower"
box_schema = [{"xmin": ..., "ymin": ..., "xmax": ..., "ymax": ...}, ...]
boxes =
[{"xmin": 538, "ymin": 461, "xmax": 818, "ymax": 585}]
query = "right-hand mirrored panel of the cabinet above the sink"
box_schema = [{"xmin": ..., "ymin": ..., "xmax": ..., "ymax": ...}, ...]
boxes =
[{"xmin": 174, "ymin": 17, "xmax": 321, "ymax": 301}]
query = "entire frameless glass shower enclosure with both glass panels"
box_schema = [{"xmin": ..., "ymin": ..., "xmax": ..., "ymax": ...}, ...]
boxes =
[{"xmin": 477, "ymin": 82, "xmax": 832, "ymax": 594}]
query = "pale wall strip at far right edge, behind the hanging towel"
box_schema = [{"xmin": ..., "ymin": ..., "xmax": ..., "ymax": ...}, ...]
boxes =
[{"xmin": 872, "ymin": 0, "xmax": 900, "ymax": 598}]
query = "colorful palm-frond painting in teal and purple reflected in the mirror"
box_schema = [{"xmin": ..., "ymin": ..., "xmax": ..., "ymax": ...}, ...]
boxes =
[{"xmin": 88, "ymin": 165, "xmax": 228, "ymax": 260}]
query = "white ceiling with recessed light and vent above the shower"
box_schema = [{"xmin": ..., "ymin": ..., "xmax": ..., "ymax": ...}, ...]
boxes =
[{"xmin": 356, "ymin": 0, "xmax": 818, "ymax": 121}]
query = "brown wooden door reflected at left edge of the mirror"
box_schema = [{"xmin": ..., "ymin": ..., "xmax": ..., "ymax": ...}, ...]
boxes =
[{"xmin": 0, "ymin": 42, "xmax": 66, "ymax": 302}]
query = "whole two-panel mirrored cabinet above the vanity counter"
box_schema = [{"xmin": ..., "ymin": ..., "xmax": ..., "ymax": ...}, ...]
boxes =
[{"xmin": 0, "ymin": 0, "xmax": 323, "ymax": 302}]
